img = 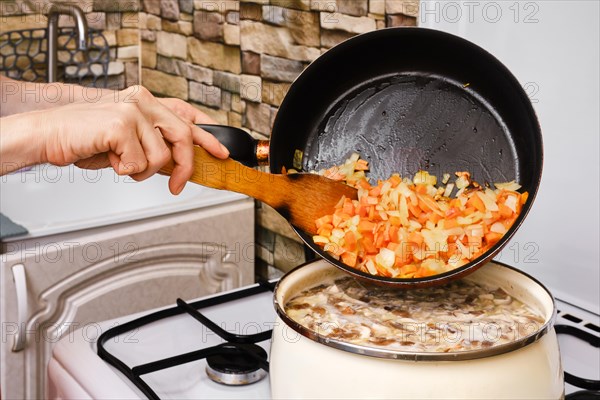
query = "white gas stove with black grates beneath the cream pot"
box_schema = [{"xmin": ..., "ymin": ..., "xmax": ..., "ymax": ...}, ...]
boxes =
[{"xmin": 47, "ymin": 282, "xmax": 600, "ymax": 399}]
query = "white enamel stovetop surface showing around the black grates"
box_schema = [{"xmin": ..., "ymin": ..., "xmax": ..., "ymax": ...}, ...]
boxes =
[{"xmin": 49, "ymin": 286, "xmax": 600, "ymax": 399}]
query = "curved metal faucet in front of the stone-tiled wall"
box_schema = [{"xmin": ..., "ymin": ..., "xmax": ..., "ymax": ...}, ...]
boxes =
[{"xmin": 48, "ymin": 4, "xmax": 88, "ymax": 82}]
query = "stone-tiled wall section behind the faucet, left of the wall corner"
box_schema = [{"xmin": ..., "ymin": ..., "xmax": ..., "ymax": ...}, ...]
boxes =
[{"xmin": 0, "ymin": 0, "xmax": 140, "ymax": 89}]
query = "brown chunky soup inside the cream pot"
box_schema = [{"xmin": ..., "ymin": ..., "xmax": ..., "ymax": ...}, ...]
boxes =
[{"xmin": 285, "ymin": 277, "xmax": 544, "ymax": 352}]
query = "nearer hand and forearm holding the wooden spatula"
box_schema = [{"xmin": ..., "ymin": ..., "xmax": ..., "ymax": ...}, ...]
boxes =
[{"xmin": 2, "ymin": 86, "xmax": 229, "ymax": 194}]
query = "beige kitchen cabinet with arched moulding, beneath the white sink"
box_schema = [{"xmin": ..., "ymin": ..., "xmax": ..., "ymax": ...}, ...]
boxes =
[{"xmin": 0, "ymin": 199, "xmax": 254, "ymax": 399}]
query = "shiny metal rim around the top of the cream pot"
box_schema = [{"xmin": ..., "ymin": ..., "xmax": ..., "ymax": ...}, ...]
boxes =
[{"xmin": 273, "ymin": 260, "xmax": 557, "ymax": 361}]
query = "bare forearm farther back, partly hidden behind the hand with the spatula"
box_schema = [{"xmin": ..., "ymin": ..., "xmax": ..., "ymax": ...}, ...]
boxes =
[{"xmin": 0, "ymin": 75, "xmax": 114, "ymax": 117}]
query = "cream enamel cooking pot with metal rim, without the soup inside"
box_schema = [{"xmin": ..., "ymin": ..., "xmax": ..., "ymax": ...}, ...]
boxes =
[{"xmin": 270, "ymin": 260, "xmax": 564, "ymax": 400}]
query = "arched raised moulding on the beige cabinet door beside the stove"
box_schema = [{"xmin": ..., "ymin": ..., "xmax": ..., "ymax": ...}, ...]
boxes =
[{"xmin": 2, "ymin": 244, "xmax": 246, "ymax": 399}]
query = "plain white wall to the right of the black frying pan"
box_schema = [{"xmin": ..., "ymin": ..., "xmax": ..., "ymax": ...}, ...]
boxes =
[{"xmin": 419, "ymin": 0, "xmax": 600, "ymax": 314}]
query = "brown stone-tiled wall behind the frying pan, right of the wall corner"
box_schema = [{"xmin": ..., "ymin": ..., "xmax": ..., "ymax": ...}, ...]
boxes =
[{"xmin": 140, "ymin": 0, "xmax": 418, "ymax": 276}]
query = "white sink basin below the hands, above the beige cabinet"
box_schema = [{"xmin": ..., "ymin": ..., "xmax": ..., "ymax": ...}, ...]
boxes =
[{"xmin": 0, "ymin": 164, "xmax": 246, "ymax": 240}]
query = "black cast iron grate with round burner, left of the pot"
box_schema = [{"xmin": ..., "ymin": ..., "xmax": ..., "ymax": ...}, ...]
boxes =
[{"xmin": 98, "ymin": 282, "xmax": 274, "ymax": 400}]
